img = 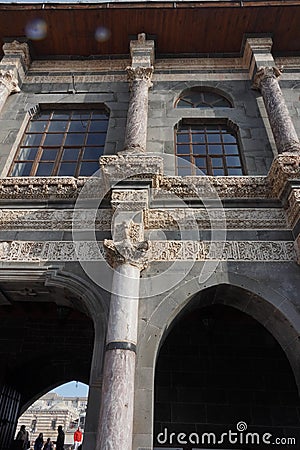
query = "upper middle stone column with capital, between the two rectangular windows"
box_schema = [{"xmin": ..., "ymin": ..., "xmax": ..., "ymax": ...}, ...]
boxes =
[{"xmin": 124, "ymin": 33, "xmax": 154, "ymax": 153}]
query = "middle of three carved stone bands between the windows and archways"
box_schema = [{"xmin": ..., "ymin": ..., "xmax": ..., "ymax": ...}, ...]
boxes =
[{"xmin": 0, "ymin": 206, "xmax": 288, "ymax": 231}]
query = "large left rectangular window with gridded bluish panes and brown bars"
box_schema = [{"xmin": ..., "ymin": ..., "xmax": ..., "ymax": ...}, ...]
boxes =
[{"xmin": 9, "ymin": 105, "xmax": 109, "ymax": 177}]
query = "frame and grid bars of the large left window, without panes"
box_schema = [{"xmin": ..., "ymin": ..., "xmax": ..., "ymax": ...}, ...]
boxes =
[{"xmin": 7, "ymin": 103, "xmax": 110, "ymax": 178}]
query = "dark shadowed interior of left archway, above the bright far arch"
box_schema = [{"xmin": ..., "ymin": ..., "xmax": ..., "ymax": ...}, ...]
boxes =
[{"xmin": 0, "ymin": 285, "xmax": 94, "ymax": 450}]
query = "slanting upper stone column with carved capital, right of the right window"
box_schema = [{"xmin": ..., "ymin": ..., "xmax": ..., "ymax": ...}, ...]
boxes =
[{"xmin": 253, "ymin": 67, "xmax": 300, "ymax": 153}]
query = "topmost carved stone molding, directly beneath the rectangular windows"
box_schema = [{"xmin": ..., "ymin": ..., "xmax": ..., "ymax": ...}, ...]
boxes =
[{"xmin": 0, "ymin": 173, "xmax": 274, "ymax": 200}]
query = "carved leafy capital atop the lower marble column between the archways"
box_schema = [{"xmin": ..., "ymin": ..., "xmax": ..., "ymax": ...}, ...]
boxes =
[{"xmin": 103, "ymin": 220, "xmax": 149, "ymax": 271}]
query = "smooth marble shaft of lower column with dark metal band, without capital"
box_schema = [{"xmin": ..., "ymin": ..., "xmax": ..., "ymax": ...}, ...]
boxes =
[{"xmin": 97, "ymin": 263, "xmax": 140, "ymax": 450}]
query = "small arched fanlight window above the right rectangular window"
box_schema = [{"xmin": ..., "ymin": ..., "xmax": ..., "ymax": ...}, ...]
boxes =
[{"xmin": 175, "ymin": 87, "xmax": 232, "ymax": 108}]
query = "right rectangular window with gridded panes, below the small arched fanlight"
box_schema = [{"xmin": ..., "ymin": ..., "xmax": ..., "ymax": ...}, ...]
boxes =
[{"xmin": 176, "ymin": 119, "xmax": 245, "ymax": 176}]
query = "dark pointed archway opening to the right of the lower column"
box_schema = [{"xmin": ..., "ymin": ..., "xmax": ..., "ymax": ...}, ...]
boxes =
[{"xmin": 154, "ymin": 298, "xmax": 300, "ymax": 450}]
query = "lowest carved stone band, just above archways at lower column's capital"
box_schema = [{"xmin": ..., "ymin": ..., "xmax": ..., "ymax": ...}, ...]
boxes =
[{"xmin": 0, "ymin": 239, "xmax": 292, "ymax": 264}]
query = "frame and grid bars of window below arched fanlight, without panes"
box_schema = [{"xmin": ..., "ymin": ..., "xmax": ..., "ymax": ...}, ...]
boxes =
[{"xmin": 174, "ymin": 118, "xmax": 247, "ymax": 177}]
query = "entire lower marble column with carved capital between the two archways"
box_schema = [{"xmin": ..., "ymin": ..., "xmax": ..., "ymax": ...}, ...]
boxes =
[{"xmin": 96, "ymin": 214, "xmax": 149, "ymax": 450}]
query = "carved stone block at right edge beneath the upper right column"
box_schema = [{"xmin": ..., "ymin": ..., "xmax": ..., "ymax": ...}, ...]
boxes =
[{"xmin": 268, "ymin": 153, "xmax": 300, "ymax": 198}]
